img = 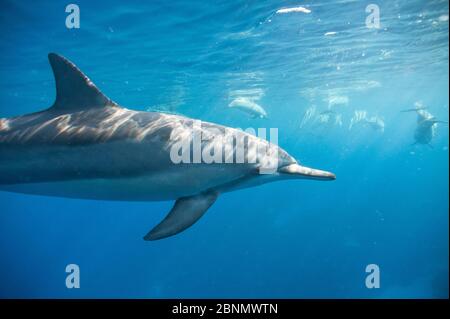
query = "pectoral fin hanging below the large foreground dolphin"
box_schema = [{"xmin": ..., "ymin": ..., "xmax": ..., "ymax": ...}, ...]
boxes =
[{"xmin": 144, "ymin": 191, "xmax": 219, "ymax": 240}]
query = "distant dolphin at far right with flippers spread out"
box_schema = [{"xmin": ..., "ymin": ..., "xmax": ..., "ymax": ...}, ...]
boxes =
[{"xmin": 401, "ymin": 107, "xmax": 448, "ymax": 148}]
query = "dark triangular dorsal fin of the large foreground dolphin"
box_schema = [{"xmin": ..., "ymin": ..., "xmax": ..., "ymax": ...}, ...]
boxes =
[{"xmin": 48, "ymin": 53, "xmax": 117, "ymax": 110}]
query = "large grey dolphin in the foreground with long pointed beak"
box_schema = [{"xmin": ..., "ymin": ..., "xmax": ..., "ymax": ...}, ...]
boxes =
[{"xmin": 0, "ymin": 53, "xmax": 335, "ymax": 240}]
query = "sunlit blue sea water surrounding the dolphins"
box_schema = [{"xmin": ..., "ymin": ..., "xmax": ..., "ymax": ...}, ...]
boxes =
[{"xmin": 0, "ymin": 0, "xmax": 449, "ymax": 298}]
